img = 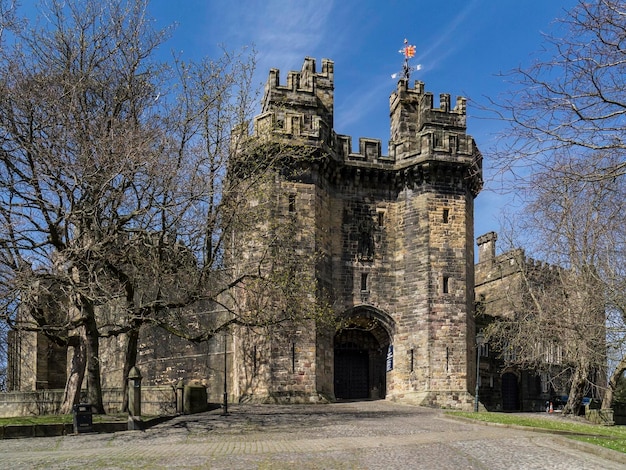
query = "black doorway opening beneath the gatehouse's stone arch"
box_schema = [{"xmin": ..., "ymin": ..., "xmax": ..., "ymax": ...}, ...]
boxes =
[{"xmin": 334, "ymin": 326, "xmax": 388, "ymax": 400}]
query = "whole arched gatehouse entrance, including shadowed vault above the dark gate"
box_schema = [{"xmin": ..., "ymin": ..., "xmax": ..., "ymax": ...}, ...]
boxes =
[{"xmin": 334, "ymin": 308, "xmax": 393, "ymax": 400}]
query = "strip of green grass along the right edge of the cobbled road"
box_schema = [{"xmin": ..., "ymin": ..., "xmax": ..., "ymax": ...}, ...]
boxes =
[{"xmin": 446, "ymin": 411, "xmax": 626, "ymax": 454}]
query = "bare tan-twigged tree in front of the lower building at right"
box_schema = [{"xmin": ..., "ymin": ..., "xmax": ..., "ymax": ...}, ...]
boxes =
[{"xmin": 480, "ymin": 174, "xmax": 624, "ymax": 413}]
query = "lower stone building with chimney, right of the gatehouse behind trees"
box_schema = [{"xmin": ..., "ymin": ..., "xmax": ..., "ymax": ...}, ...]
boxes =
[{"xmin": 475, "ymin": 232, "xmax": 606, "ymax": 411}]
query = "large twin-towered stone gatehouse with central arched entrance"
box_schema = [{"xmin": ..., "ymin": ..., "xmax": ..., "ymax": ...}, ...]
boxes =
[{"xmin": 235, "ymin": 58, "xmax": 482, "ymax": 409}]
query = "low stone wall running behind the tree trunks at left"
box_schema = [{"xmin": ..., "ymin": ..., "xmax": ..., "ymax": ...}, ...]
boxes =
[{"xmin": 0, "ymin": 386, "xmax": 176, "ymax": 418}]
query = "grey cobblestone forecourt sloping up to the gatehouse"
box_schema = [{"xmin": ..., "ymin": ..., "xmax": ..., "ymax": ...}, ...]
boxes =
[{"xmin": 0, "ymin": 401, "xmax": 626, "ymax": 470}]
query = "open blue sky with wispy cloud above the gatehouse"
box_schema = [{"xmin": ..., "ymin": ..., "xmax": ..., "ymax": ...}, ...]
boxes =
[{"xmin": 17, "ymin": 0, "xmax": 576, "ymax": 248}]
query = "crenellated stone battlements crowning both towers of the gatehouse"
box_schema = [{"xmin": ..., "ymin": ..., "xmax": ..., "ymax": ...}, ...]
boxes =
[{"xmin": 254, "ymin": 57, "xmax": 482, "ymax": 190}]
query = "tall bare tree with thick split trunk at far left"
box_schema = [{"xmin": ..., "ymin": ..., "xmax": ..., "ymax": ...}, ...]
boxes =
[{"xmin": 0, "ymin": 1, "xmax": 173, "ymax": 411}]
